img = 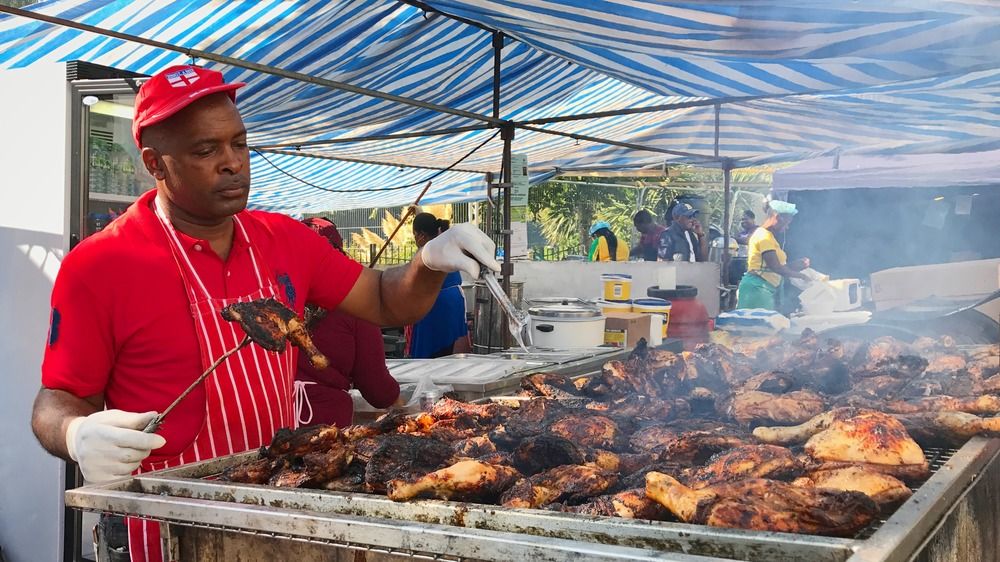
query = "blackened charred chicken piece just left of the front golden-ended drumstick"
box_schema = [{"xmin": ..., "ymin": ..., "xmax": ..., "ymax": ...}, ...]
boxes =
[{"xmin": 365, "ymin": 434, "xmax": 454, "ymax": 492}]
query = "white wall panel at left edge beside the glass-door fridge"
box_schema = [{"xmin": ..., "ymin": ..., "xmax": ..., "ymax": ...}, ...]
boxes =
[{"xmin": 0, "ymin": 64, "xmax": 69, "ymax": 562}]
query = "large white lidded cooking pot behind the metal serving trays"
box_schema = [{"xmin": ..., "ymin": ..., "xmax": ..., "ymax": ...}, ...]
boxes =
[{"xmin": 528, "ymin": 299, "xmax": 605, "ymax": 349}]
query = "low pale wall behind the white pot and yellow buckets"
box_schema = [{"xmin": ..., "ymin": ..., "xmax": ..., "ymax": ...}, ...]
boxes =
[{"xmin": 513, "ymin": 261, "xmax": 719, "ymax": 317}]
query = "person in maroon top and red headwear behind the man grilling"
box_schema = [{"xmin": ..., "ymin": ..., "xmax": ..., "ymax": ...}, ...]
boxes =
[{"xmin": 295, "ymin": 217, "xmax": 399, "ymax": 427}]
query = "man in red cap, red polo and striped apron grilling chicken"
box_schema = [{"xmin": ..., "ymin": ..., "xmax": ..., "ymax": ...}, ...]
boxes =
[{"xmin": 32, "ymin": 65, "xmax": 499, "ymax": 561}]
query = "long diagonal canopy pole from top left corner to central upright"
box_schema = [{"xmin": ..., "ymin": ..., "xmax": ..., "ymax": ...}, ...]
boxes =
[{"xmin": 0, "ymin": 5, "xmax": 504, "ymax": 125}]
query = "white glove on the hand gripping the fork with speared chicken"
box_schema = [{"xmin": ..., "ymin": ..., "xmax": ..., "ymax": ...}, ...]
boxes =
[{"xmin": 66, "ymin": 410, "xmax": 167, "ymax": 484}]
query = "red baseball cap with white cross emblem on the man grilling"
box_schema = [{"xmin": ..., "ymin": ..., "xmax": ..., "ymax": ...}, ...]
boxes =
[{"xmin": 132, "ymin": 64, "xmax": 246, "ymax": 148}]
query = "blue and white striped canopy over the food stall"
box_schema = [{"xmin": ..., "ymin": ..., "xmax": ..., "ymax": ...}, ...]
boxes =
[{"xmin": 0, "ymin": 0, "xmax": 1000, "ymax": 213}]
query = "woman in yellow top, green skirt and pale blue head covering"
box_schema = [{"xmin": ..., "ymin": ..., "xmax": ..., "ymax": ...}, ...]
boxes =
[{"xmin": 736, "ymin": 201, "xmax": 809, "ymax": 310}]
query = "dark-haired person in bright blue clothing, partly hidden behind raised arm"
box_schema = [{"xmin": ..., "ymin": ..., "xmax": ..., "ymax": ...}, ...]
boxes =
[{"xmin": 406, "ymin": 213, "xmax": 472, "ymax": 359}]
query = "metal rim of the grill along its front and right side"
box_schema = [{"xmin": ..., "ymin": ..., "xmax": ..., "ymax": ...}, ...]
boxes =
[{"xmin": 66, "ymin": 438, "xmax": 1000, "ymax": 562}]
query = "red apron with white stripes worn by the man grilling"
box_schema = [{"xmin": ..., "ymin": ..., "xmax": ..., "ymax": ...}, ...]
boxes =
[{"xmin": 128, "ymin": 203, "xmax": 297, "ymax": 562}]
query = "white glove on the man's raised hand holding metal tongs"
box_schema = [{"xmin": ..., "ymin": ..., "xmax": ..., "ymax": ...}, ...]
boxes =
[{"xmin": 421, "ymin": 223, "xmax": 500, "ymax": 279}]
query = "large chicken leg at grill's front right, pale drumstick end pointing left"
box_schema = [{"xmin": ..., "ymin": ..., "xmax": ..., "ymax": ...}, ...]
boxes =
[{"xmin": 646, "ymin": 472, "xmax": 879, "ymax": 537}]
